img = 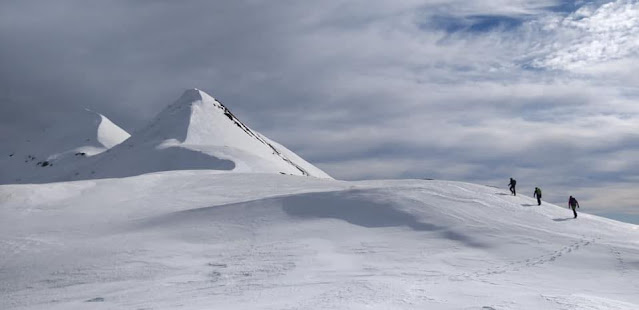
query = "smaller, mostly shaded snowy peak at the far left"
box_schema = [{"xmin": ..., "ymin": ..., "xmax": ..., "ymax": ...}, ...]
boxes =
[{"xmin": 0, "ymin": 110, "xmax": 130, "ymax": 184}]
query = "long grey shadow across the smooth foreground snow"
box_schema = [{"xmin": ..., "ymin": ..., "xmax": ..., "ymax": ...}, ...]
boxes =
[{"xmin": 136, "ymin": 190, "xmax": 486, "ymax": 247}]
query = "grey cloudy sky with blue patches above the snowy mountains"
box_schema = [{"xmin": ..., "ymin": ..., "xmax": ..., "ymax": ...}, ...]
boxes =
[{"xmin": 0, "ymin": 0, "xmax": 639, "ymax": 213}]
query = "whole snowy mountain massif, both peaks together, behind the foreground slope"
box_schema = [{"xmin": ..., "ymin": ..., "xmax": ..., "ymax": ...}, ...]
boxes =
[{"xmin": 0, "ymin": 89, "xmax": 331, "ymax": 184}]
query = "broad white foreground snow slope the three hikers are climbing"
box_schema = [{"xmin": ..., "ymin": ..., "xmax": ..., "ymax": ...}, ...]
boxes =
[{"xmin": 0, "ymin": 170, "xmax": 639, "ymax": 309}]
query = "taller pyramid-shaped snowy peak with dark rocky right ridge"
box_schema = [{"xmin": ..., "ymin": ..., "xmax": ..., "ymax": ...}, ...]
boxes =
[{"xmin": 60, "ymin": 89, "xmax": 330, "ymax": 180}]
